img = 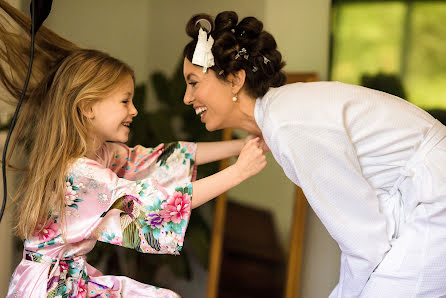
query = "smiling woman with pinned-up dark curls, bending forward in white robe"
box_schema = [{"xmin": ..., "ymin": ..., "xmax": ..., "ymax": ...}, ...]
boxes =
[{"xmin": 184, "ymin": 12, "xmax": 446, "ymax": 297}]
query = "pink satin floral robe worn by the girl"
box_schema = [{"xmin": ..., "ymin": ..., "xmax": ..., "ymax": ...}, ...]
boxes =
[{"xmin": 7, "ymin": 142, "xmax": 196, "ymax": 298}]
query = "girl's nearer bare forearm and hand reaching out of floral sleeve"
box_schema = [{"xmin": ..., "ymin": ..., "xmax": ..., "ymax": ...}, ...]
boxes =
[{"xmin": 192, "ymin": 138, "xmax": 266, "ymax": 208}]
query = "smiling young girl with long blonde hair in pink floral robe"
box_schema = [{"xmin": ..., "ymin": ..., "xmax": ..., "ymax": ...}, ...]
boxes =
[{"xmin": 0, "ymin": 2, "xmax": 266, "ymax": 297}]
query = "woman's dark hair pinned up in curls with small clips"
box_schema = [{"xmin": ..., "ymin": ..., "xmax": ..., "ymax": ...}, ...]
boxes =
[{"xmin": 183, "ymin": 11, "xmax": 286, "ymax": 97}]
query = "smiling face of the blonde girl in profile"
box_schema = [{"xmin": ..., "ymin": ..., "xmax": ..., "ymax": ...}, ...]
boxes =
[{"xmin": 89, "ymin": 75, "xmax": 138, "ymax": 144}]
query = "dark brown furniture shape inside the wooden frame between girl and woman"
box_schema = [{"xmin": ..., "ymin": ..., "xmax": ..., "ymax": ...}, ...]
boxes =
[{"xmin": 217, "ymin": 199, "xmax": 286, "ymax": 298}]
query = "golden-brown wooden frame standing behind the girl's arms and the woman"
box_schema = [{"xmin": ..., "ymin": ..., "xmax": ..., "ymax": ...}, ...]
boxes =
[{"xmin": 206, "ymin": 72, "xmax": 318, "ymax": 298}]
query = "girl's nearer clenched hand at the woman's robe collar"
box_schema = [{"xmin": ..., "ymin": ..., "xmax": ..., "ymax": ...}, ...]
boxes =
[{"xmin": 233, "ymin": 137, "xmax": 266, "ymax": 181}]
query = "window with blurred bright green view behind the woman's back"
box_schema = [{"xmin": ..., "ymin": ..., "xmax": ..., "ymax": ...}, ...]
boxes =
[{"xmin": 331, "ymin": 0, "xmax": 446, "ymax": 109}]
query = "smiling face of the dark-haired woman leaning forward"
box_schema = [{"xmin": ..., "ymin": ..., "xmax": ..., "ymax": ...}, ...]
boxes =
[{"xmin": 183, "ymin": 58, "xmax": 236, "ymax": 131}]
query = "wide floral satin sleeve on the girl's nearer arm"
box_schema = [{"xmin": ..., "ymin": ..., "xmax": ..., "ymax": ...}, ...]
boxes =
[{"xmin": 66, "ymin": 142, "xmax": 196, "ymax": 254}]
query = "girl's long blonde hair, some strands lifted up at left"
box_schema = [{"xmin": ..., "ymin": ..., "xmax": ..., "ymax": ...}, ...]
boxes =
[{"xmin": 0, "ymin": 1, "xmax": 134, "ymax": 238}]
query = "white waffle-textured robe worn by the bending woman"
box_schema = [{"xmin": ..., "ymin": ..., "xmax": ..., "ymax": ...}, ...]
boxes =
[{"xmin": 255, "ymin": 82, "xmax": 446, "ymax": 298}]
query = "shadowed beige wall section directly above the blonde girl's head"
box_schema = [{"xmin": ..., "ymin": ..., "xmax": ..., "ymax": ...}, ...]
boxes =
[{"xmin": 45, "ymin": 0, "xmax": 151, "ymax": 86}]
